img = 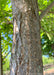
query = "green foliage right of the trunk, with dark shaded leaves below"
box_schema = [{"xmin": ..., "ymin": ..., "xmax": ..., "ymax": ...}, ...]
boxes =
[{"xmin": 38, "ymin": 0, "xmax": 54, "ymax": 56}]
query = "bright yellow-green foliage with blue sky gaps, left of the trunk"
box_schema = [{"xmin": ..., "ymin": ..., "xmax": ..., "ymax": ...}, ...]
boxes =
[{"xmin": 0, "ymin": 0, "xmax": 13, "ymax": 70}]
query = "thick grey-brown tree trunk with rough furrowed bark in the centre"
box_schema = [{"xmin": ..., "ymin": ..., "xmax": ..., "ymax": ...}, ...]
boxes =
[{"xmin": 10, "ymin": 0, "xmax": 43, "ymax": 75}]
